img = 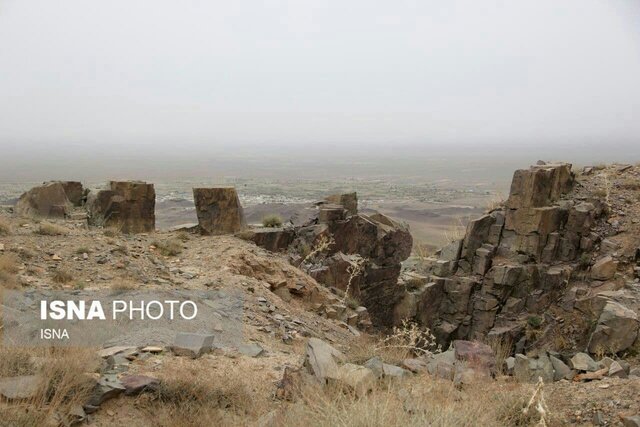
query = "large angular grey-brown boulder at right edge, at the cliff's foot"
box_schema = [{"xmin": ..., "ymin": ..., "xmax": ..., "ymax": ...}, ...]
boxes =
[{"xmin": 589, "ymin": 301, "xmax": 640, "ymax": 353}]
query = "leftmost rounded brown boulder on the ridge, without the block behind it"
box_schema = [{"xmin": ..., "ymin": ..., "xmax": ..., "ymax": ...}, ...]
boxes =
[{"xmin": 15, "ymin": 182, "xmax": 73, "ymax": 218}]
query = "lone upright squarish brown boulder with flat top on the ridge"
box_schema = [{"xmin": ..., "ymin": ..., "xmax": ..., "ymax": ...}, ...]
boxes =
[{"xmin": 193, "ymin": 187, "xmax": 246, "ymax": 235}]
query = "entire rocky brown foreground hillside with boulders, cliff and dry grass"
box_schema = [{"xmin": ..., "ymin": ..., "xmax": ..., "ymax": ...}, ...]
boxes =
[{"xmin": 0, "ymin": 164, "xmax": 640, "ymax": 426}]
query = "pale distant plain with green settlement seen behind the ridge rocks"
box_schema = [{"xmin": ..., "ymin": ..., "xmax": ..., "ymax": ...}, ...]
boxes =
[{"xmin": 0, "ymin": 177, "xmax": 501, "ymax": 248}]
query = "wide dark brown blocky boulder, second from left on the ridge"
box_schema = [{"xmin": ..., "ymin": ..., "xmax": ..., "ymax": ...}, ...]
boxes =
[{"xmin": 86, "ymin": 181, "xmax": 156, "ymax": 233}]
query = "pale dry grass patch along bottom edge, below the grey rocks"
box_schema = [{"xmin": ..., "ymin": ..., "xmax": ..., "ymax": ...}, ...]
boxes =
[{"xmin": 275, "ymin": 376, "xmax": 537, "ymax": 427}]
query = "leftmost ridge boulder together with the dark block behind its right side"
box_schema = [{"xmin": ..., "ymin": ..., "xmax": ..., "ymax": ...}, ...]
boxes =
[{"xmin": 15, "ymin": 181, "xmax": 83, "ymax": 218}]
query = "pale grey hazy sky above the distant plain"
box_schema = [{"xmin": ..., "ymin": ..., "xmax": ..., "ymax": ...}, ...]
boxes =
[{"xmin": 0, "ymin": 0, "xmax": 640, "ymax": 180}]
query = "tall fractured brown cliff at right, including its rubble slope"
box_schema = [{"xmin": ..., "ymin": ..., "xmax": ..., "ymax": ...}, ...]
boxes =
[{"xmin": 398, "ymin": 163, "xmax": 640, "ymax": 353}]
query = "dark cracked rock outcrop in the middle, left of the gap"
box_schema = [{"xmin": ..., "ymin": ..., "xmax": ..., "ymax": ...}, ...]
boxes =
[{"xmin": 239, "ymin": 193, "xmax": 413, "ymax": 326}]
